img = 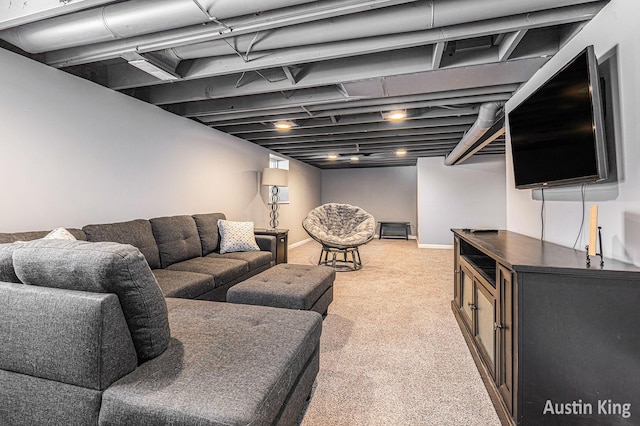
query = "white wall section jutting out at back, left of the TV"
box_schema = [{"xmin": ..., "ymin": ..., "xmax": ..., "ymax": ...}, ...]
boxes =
[{"xmin": 418, "ymin": 155, "xmax": 506, "ymax": 246}]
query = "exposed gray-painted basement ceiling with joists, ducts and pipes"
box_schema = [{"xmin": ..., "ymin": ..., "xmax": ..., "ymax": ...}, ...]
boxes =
[{"xmin": 0, "ymin": 0, "xmax": 607, "ymax": 168}]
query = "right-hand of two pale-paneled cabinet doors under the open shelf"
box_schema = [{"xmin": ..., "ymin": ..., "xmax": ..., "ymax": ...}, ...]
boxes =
[{"xmin": 474, "ymin": 277, "xmax": 497, "ymax": 379}]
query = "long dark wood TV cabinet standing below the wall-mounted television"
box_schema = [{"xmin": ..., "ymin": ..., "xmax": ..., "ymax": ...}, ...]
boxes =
[{"xmin": 452, "ymin": 230, "xmax": 640, "ymax": 425}]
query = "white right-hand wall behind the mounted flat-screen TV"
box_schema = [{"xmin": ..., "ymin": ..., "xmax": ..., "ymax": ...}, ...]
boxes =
[{"xmin": 506, "ymin": 0, "xmax": 640, "ymax": 264}]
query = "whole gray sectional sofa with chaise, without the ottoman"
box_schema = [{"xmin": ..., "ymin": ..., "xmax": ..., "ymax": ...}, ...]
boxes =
[{"xmin": 0, "ymin": 214, "xmax": 322, "ymax": 425}]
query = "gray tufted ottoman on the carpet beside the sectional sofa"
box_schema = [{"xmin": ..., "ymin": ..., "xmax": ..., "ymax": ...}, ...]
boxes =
[{"xmin": 227, "ymin": 263, "xmax": 336, "ymax": 315}]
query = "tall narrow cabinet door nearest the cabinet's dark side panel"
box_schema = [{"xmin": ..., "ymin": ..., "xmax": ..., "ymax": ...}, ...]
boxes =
[{"xmin": 496, "ymin": 265, "xmax": 514, "ymax": 412}]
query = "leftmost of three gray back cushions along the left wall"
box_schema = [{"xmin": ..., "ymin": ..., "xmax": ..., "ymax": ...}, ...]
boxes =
[{"xmin": 82, "ymin": 219, "xmax": 160, "ymax": 269}]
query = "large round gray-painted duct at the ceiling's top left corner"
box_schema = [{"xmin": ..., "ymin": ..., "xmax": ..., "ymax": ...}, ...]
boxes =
[{"xmin": 0, "ymin": 0, "xmax": 318, "ymax": 53}]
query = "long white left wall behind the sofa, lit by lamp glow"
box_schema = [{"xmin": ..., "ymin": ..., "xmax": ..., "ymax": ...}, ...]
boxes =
[{"xmin": 0, "ymin": 49, "xmax": 320, "ymax": 243}]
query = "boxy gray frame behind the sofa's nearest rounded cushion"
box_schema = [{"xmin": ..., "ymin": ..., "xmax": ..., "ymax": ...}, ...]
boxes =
[{"xmin": 0, "ymin": 282, "xmax": 138, "ymax": 390}]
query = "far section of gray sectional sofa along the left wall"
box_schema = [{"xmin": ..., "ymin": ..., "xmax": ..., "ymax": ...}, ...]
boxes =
[{"xmin": 0, "ymin": 213, "xmax": 276, "ymax": 301}]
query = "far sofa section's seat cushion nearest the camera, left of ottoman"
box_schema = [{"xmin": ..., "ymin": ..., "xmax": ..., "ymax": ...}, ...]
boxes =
[{"xmin": 151, "ymin": 269, "xmax": 215, "ymax": 299}]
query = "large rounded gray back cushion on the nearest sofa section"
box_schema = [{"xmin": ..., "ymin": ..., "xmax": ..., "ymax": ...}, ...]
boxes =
[{"xmin": 13, "ymin": 240, "xmax": 170, "ymax": 362}]
